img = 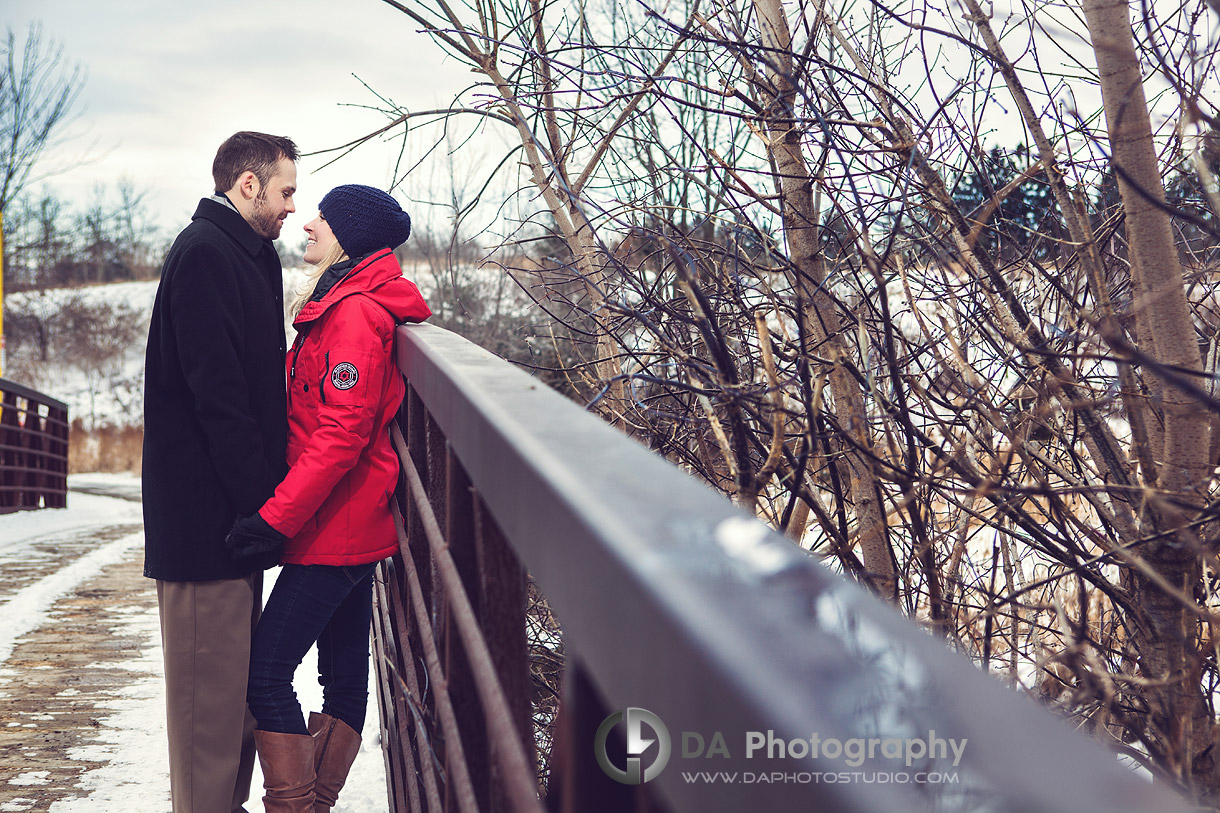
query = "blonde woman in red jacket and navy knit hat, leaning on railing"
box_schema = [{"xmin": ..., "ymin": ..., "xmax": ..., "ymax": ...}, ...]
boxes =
[{"xmin": 228, "ymin": 186, "xmax": 432, "ymax": 813}]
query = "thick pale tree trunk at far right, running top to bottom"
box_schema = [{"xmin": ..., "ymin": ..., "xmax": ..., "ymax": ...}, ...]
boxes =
[{"xmin": 1082, "ymin": 0, "xmax": 1218, "ymax": 798}]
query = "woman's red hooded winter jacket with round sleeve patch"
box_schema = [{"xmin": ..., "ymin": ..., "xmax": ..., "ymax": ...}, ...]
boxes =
[{"xmin": 259, "ymin": 249, "xmax": 432, "ymax": 565}]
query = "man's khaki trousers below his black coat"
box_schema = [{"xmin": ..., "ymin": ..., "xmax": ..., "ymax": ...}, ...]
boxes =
[{"xmin": 156, "ymin": 571, "xmax": 262, "ymax": 813}]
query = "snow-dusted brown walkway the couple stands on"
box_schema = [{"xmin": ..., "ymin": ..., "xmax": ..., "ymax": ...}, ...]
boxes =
[{"xmin": 0, "ymin": 475, "xmax": 387, "ymax": 813}]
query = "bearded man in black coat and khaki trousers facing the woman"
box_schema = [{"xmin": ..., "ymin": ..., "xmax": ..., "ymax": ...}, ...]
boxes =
[{"xmin": 143, "ymin": 132, "xmax": 299, "ymax": 813}]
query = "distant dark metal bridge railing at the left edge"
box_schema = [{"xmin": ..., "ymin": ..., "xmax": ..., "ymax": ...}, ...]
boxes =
[{"xmin": 0, "ymin": 378, "xmax": 68, "ymax": 514}]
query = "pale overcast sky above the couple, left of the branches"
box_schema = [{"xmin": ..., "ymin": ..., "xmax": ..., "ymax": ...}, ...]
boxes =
[{"xmin": 7, "ymin": 0, "xmax": 471, "ymax": 244}]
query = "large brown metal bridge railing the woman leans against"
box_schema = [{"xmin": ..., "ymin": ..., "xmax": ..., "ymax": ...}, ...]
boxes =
[{"xmin": 375, "ymin": 325, "xmax": 1192, "ymax": 813}]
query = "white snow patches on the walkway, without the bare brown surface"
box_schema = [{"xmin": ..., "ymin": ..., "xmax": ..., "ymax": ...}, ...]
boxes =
[{"xmin": 0, "ymin": 475, "xmax": 388, "ymax": 813}]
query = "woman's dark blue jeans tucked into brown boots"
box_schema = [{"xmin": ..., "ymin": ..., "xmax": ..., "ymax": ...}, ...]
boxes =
[{"xmin": 246, "ymin": 563, "xmax": 377, "ymax": 734}]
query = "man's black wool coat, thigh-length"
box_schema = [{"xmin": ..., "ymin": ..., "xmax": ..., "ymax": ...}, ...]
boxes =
[{"xmin": 143, "ymin": 198, "xmax": 288, "ymax": 581}]
